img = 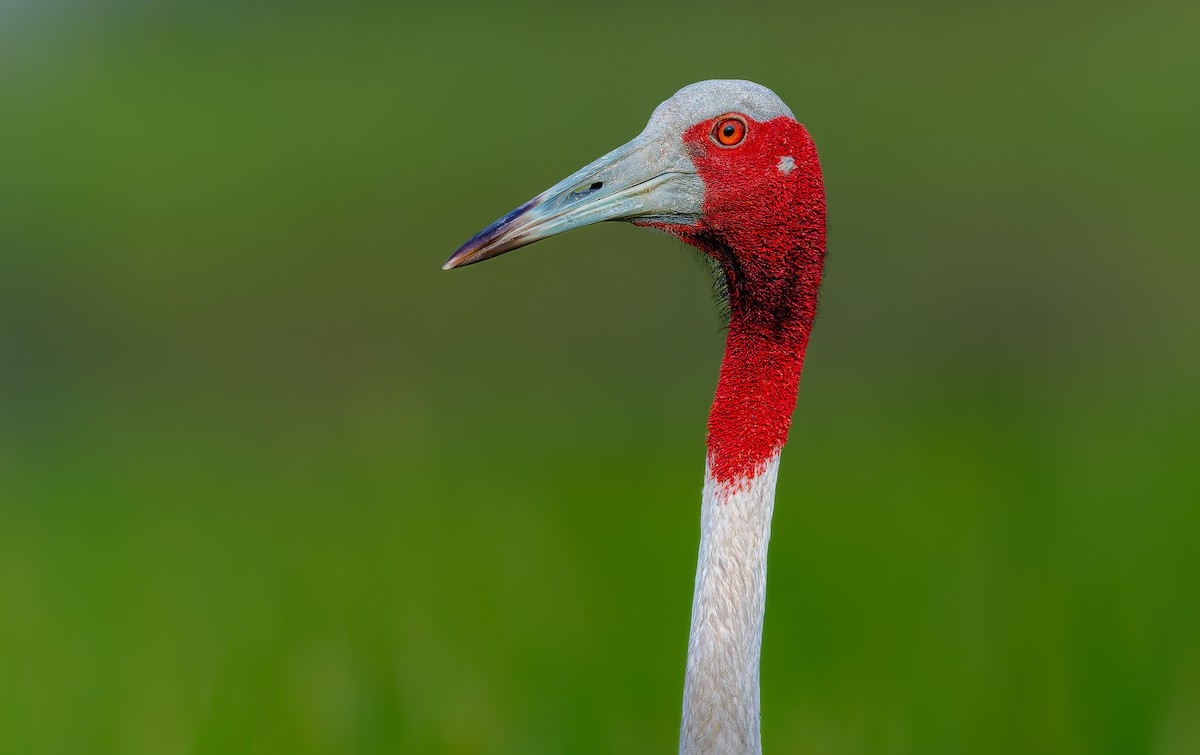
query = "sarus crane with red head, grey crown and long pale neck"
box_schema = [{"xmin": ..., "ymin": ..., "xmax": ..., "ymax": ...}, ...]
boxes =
[{"xmin": 444, "ymin": 80, "xmax": 826, "ymax": 755}]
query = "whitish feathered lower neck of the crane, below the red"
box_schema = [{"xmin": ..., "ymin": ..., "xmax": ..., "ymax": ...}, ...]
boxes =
[{"xmin": 679, "ymin": 451, "xmax": 779, "ymax": 755}]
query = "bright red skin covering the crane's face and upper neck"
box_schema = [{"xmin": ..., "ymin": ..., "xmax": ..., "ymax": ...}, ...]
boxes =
[{"xmin": 653, "ymin": 116, "xmax": 826, "ymax": 486}]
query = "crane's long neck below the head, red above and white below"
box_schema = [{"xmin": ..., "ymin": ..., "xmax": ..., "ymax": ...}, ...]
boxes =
[{"xmin": 679, "ymin": 168, "xmax": 826, "ymax": 755}]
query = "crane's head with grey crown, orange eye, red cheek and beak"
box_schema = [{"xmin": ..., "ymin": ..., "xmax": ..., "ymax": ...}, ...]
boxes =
[{"xmin": 443, "ymin": 80, "xmax": 824, "ymax": 299}]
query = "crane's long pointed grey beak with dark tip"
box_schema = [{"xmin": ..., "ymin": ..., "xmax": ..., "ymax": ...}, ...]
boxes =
[{"xmin": 442, "ymin": 133, "xmax": 704, "ymax": 270}]
